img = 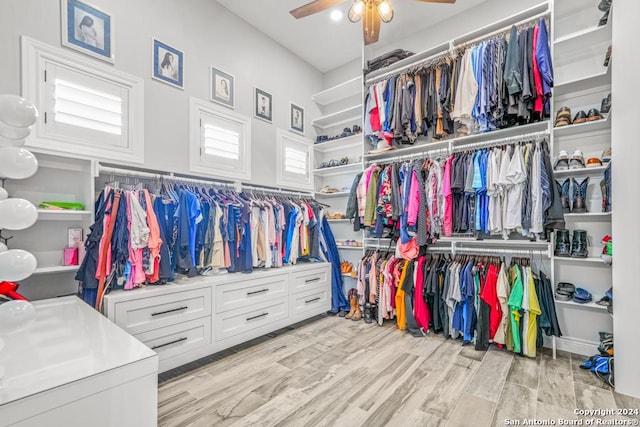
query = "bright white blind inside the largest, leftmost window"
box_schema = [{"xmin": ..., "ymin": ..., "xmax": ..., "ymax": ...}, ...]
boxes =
[{"xmin": 54, "ymin": 78, "xmax": 122, "ymax": 135}]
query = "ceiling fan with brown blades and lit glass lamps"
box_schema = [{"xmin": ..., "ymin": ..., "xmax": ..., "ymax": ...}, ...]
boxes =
[{"xmin": 289, "ymin": 0, "xmax": 456, "ymax": 45}]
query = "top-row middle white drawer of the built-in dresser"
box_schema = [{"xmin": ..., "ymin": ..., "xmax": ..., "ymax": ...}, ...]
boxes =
[{"xmin": 215, "ymin": 274, "xmax": 289, "ymax": 313}]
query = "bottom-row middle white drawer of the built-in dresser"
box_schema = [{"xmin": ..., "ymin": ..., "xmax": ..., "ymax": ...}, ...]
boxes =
[{"xmin": 216, "ymin": 298, "xmax": 289, "ymax": 340}]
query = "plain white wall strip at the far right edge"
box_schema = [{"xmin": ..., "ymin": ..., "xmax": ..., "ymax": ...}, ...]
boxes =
[{"xmin": 611, "ymin": 0, "xmax": 640, "ymax": 397}]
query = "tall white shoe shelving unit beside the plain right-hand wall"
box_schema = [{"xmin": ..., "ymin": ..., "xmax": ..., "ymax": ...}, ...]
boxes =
[{"xmin": 551, "ymin": 0, "xmax": 615, "ymax": 356}]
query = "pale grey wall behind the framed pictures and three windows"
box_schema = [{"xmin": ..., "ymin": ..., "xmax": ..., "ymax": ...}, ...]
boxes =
[{"xmin": 0, "ymin": 0, "xmax": 322, "ymax": 185}]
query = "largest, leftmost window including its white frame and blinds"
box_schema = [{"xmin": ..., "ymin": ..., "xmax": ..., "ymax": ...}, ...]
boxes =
[{"xmin": 22, "ymin": 37, "xmax": 144, "ymax": 163}]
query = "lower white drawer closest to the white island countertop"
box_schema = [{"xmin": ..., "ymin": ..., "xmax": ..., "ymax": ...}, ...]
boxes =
[{"xmin": 135, "ymin": 316, "xmax": 212, "ymax": 359}]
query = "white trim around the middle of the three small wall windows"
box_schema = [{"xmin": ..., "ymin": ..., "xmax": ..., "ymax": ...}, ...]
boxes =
[{"xmin": 189, "ymin": 97, "xmax": 251, "ymax": 181}]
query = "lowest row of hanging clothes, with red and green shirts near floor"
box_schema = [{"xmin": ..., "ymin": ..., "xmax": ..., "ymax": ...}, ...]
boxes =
[{"xmin": 357, "ymin": 249, "xmax": 562, "ymax": 357}]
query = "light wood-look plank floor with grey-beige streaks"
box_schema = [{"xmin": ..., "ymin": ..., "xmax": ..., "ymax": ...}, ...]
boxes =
[{"xmin": 158, "ymin": 317, "xmax": 640, "ymax": 427}]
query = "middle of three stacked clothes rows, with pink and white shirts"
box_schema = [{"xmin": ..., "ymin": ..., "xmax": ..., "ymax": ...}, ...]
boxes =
[{"xmin": 346, "ymin": 138, "xmax": 564, "ymax": 246}]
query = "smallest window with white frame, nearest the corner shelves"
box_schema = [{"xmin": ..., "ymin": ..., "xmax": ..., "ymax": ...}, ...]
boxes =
[{"xmin": 277, "ymin": 129, "xmax": 312, "ymax": 190}]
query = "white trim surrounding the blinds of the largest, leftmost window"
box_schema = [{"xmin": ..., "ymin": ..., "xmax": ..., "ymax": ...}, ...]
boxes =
[{"xmin": 21, "ymin": 36, "xmax": 144, "ymax": 164}]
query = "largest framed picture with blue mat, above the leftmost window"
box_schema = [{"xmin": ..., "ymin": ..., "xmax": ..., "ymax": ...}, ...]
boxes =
[{"xmin": 60, "ymin": 0, "xmax": 114, "ymax": 63}]
